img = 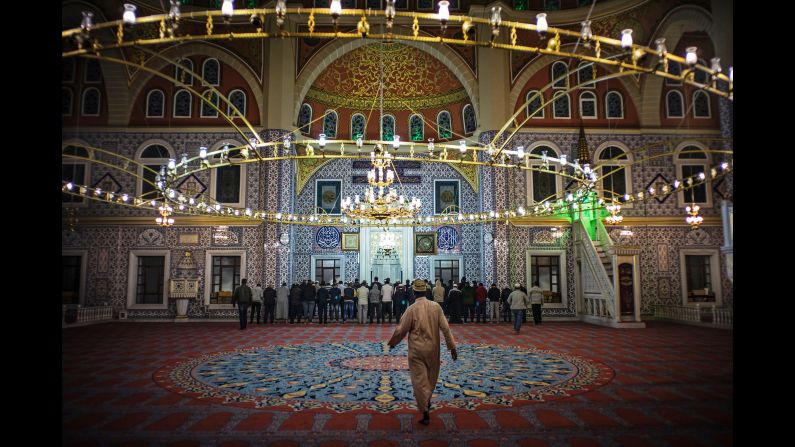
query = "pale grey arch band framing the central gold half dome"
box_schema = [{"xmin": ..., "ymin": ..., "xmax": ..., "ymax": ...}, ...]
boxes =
[{"xmin": 293, "ymin": 39, "xmax": 480, "ymax": 128}]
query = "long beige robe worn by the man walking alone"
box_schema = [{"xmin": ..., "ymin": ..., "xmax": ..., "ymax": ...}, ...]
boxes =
[{"xmin": 389, "ymin": 297, "xmax": 455, "ymax": 411}]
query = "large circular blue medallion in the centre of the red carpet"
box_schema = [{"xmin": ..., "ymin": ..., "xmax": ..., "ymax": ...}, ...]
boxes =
[{"xmin": 155, "ymin": 342, "xmax": 613, "ymax": 413}]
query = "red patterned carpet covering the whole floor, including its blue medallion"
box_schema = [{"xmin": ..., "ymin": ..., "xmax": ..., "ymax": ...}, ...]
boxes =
[{"xmin": 62, "ymin": 322, "xmax": 733, "ymax": 447}]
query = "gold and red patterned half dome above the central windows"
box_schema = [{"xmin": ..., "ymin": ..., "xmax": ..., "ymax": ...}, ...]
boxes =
[{"xmin": 306, "ymin": 42, "xmax": 468, "ymax": 110}]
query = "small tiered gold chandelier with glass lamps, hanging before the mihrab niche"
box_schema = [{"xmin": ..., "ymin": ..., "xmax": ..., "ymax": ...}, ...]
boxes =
[{"xmin": 342, "ymin": 144, "xmax": 422, "ymax": 221}]
